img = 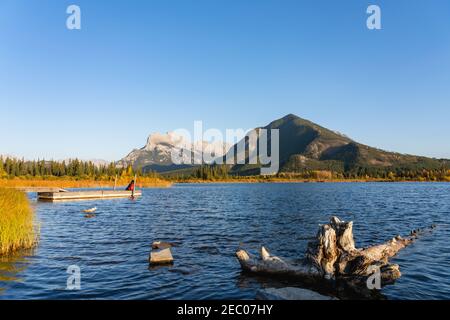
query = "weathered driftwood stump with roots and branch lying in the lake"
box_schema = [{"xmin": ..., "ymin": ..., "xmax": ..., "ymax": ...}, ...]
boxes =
[{"xmin": 236, "ymin": 217, "xmax": 435, "ymax": 296}]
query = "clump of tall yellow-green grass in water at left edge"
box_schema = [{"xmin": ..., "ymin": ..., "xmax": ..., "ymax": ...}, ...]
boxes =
[{"xmin": 0, "ymin": 188, "xmax": 37, "ymax": 255}]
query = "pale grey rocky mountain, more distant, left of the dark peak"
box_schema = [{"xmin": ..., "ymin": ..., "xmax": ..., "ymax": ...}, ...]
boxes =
[{"xmin": 117, "ymin": 132, "xmax": 230, "ymax": 172}]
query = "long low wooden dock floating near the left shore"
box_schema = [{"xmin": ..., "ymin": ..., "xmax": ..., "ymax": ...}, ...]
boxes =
[{"xmin": 38, "ymin": 190, "xmax": 142, "ymax": 202}]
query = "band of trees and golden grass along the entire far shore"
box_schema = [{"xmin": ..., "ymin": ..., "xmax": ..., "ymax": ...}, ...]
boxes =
[{"xmin": 0, "ymin": 157, "xmax": 450, "ymax": 188}]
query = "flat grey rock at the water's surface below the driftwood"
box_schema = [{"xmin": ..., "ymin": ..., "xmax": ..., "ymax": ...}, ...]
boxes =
[{"xmin": 256, "ymin": 287, "xmax": 337, "ymax": 300}]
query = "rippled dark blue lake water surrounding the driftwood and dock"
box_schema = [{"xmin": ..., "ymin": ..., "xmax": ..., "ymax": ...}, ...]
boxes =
[{"xmin": 0, "ymin": 183, "xmax": 450, "ymax": 299}]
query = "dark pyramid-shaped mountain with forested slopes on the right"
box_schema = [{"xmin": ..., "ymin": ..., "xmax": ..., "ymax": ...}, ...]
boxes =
[{"xmin": 232, "ymin": 114, "xmax": 450, "ymax": 176}]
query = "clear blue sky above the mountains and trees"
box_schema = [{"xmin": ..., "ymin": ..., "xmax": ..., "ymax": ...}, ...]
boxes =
[{"xmin": 0, "ymin": 0, "xmax": 450, "ymax": 160}]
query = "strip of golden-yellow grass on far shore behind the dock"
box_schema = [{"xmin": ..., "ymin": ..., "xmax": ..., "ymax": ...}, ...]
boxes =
[{"xmin": 0, "ymin": 177, "xmax": 172, "ymax": 189}]
